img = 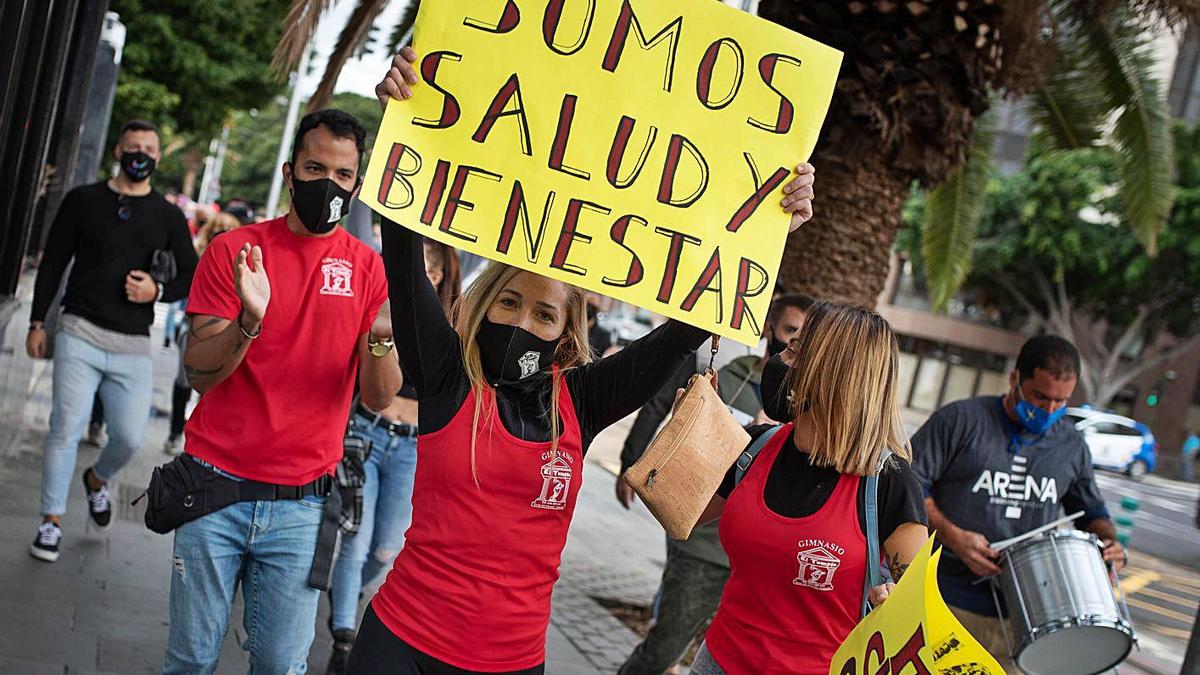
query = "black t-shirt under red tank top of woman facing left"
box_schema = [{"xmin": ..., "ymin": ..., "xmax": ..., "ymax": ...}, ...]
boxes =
[{"xmin": 716, "ymin": 424, "xmax": 929, "ymax": 538}]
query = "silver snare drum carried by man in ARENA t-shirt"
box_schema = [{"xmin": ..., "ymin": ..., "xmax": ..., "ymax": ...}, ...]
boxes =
[{"xmin": 998, "ymin": 530, "xmax": 1136, "ymax": 675}]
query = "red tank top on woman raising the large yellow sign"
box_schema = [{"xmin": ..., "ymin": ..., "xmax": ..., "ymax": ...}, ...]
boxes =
[{"xmin": 371, "ymin": 374, "xmax": 583, "ymax": 673}]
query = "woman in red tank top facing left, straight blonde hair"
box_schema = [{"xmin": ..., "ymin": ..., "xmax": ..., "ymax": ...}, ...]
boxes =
[{"xmin": 692, "ymin": 303, "xmax": 929, "ymax": 675}]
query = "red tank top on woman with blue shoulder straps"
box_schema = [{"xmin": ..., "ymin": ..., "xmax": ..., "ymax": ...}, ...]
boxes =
[{"xmin": 706, "ymin": 424, "xmax": 866, "ymax": 675}]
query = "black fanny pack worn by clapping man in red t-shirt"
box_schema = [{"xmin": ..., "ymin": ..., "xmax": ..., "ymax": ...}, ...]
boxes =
[{"xmin": 133, "ymin": 454, "xmax": 332, "ymax": 534}]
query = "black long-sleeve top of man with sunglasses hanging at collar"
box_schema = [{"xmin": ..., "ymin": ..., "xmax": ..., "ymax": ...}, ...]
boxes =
[{"xmin": 29, "ymin": 183, "xmax": 197, "ymax": 335}]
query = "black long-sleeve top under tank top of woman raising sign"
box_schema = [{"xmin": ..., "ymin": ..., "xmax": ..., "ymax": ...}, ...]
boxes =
[{"xmin": 383, "ymin": 220, "xmax": 709, "ymax": 452}]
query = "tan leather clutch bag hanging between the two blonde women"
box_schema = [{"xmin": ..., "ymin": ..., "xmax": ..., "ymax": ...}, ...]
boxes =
[{"xmin": 622, "ymin": 367, "xmax": 750, "ymax": 539}]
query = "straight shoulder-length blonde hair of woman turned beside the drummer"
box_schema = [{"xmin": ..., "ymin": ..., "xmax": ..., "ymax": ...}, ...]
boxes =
[{"xmin": 785, "ymin": 303, "xmax": 912, "ymax": 476}]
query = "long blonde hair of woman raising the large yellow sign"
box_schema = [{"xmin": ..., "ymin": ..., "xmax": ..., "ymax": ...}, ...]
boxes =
[{"xmin": 454, "ymin": 262, "xmax": 592, "ymax": 478}]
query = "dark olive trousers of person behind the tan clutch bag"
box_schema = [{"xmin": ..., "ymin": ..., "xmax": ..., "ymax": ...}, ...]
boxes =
[{"xmin": 618, "ymin": 542, "xmax": 730, "ymax": 675}]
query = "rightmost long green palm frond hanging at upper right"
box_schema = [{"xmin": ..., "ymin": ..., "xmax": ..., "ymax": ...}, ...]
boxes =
[{"xmin": 1087, "ymin": 12, "xmax": 1175, "ymax": 256}]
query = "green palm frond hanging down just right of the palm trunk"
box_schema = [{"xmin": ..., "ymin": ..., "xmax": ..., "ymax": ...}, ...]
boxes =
[{"xmin": 920, "ymin": 110, "xmax": 996, "ymax": 310}]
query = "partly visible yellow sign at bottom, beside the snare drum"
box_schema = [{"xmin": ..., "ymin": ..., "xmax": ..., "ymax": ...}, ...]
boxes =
[{"xmin": 829, "ymin": 537, "xmax": 1004, "ymax": 675}]
